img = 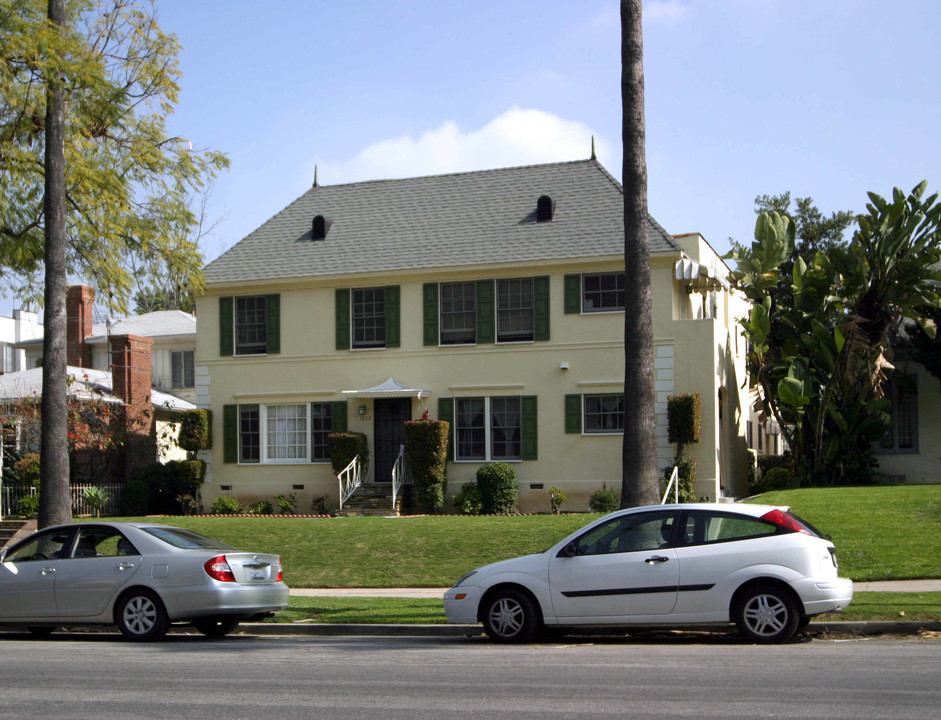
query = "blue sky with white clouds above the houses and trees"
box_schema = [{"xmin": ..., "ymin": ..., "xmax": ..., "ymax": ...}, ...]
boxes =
[{"xmin": 0, "ymin": 0, "xmax": 941, "ymax": 314}]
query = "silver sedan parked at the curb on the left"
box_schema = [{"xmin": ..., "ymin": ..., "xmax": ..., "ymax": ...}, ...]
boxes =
[{"xmin": 0, "ymin": 522, "xmax": 288, "ymax": 641}]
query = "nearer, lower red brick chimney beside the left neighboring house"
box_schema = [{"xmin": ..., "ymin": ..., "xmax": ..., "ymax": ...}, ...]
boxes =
[{"xmin": 111, "ymin": 335, "xmax": 157, "ymax": 480}]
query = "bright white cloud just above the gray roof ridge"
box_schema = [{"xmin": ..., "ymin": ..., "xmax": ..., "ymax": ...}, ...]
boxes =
[{"xmin": 319, "ymin": 106, "xmax": 609, "ymax": 185}]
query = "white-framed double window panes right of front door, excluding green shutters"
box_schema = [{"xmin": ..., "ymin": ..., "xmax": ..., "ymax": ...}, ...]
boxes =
[{"xmin": 454, "ymin": 396, "xmax": 522, "ymax": 462}]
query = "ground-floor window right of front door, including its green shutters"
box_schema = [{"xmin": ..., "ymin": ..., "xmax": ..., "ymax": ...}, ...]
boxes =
[{"xmin": 452, "ymin": 395, "xmax": 537, "ymax": 462}]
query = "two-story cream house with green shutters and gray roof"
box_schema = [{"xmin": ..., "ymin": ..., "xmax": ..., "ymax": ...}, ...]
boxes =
[{"xmin": 196, "ymin": 158, "xmax": 746, "ymax": 512}]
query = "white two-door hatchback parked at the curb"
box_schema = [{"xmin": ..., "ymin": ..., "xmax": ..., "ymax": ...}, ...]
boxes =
[{"xmin": 444, "ymin": 504, "xmax": 853, "ymax": 643}]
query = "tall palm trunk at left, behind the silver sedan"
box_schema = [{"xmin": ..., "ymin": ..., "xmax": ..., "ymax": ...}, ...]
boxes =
[{"xmin": 38, "ymin": 0, "xmax": 72, "ymax": 528}]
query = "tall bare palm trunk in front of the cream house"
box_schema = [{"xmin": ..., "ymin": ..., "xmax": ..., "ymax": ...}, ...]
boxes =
[{"xmin": 621, "ymin": 0, "xmax": 659, "ymax": 507}]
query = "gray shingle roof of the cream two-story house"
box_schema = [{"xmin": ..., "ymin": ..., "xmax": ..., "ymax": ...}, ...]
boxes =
[{"xmin": 205, "ymin": 160, "xmax": 679, "ymax": 284}]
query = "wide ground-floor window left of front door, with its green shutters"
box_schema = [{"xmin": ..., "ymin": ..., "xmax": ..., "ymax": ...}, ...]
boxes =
[{"xmin": 222, "ymin": 400, "xmax": 347, "ymax": 464}]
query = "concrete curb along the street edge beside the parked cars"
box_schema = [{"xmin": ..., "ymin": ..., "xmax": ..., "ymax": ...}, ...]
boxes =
[{"xmin": 236, "ymin": 621, "xmax": 941, "ymax": 637}]
